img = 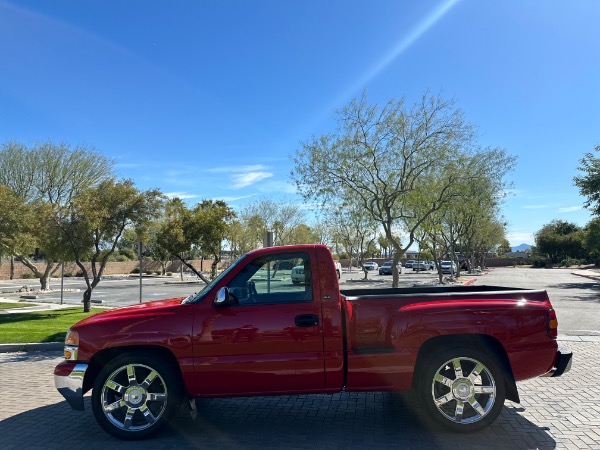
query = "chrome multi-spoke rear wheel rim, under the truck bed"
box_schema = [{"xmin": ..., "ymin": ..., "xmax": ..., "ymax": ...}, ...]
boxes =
[{"xmin": 431, "ymin": 357, "xmax": 497, "ymax": 424}]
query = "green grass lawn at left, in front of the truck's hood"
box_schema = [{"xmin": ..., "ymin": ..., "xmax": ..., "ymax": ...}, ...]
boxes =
[{"xmin": 0, "ymin": 308, "xmax": 104, "ymax": 344}]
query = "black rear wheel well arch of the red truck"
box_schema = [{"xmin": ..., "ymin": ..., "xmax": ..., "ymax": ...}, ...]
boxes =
[{"xmin": 413, "ymin": 334, "xmax": 520, "ymax": 403}]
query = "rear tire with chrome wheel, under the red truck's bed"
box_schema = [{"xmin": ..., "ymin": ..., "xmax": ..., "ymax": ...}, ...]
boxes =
[{"xmin": 416, "ymin": 347, "xmax": 506, "ymax": 433}]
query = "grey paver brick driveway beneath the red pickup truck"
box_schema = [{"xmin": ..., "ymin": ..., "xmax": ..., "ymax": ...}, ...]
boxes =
[{"xmin": 0, "ymin": 342, "xmax": 600, "ymax": 450}]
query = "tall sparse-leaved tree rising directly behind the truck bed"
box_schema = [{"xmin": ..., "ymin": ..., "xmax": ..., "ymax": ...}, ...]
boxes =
[{"xmin": 292, "ymin": 94, "xmax": 512, "ymax": 287}]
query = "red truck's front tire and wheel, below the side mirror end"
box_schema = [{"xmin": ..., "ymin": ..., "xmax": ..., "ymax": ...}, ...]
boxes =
[{"xmin": 92, "ymin": 352, "xmax": 183, "ymax": 439}]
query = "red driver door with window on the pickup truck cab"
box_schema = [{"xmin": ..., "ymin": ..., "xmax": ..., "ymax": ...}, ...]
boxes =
[{"xmin": 194, "ymin": 252, "xmax": 325, "ymax": 395}]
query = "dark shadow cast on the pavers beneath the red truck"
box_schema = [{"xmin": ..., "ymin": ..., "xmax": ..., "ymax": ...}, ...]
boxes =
[{"xmin": 0, "ymin": 392, "xmax": 556, "ymax": 450}]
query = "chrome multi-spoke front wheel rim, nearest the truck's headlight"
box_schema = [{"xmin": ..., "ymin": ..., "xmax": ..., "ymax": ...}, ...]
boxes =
[{"xmin": 100, "ymin": 364, "xmax": 168, "ymax": 432}]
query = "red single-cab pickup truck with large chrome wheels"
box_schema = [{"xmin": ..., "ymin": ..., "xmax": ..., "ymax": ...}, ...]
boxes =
[{"xmin": 54, "ymin": 245, "xmax": 572, "ymax": 439}]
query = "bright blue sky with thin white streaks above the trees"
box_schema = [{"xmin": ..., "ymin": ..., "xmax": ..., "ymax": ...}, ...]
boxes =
[{"xmin": 0, "ymin": 0, "xmax": 600, "ymax": 246}]
